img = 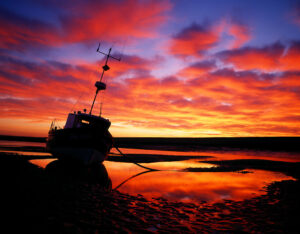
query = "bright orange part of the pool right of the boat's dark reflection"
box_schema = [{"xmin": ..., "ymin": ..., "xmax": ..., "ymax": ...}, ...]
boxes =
[{"xmin": 105, "ymin": 162, "xmax": 293, "ymax": 203}]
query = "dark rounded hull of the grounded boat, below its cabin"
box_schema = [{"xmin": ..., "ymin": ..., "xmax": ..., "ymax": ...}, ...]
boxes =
[{"xmin": 47, "ymin": 128, "xmax": 112, "ymax": 165}]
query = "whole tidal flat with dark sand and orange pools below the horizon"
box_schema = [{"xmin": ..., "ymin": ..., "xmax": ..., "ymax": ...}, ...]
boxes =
[{"xmin": 0, "ymin": 136, "xmax": 300, "ymax": 233}]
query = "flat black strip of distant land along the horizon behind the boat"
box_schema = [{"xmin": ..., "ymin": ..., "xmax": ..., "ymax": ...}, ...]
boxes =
[{"xmin": 0, "ymin": 135, "xmax": 300, "ymax": 152}]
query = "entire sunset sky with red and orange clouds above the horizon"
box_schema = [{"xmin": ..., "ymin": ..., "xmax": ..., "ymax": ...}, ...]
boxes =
[{"xmin": 0, "ymin": 0, "xmax": 300, "ymax": 137}]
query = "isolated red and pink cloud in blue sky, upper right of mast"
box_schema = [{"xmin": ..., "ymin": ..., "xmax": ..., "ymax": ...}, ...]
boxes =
[{"xmin": 169, "ymin": 18, "xmax": 252, "ymax": 58}]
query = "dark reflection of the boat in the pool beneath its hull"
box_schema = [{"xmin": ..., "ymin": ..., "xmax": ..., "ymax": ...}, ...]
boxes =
[{"xmin": 45, "ymin": 160, "xmax": 112, "ymax": 191}]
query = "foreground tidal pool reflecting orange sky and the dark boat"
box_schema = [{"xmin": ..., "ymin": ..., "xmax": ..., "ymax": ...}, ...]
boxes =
[{"xmin": 31, "ymin": 152, "xmax": 293, "ymax": 203}]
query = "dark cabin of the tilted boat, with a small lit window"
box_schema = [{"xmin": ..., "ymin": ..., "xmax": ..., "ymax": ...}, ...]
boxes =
[{"xmin": 64, "ymin": 111, "xmax": 111, "ymax": 129}]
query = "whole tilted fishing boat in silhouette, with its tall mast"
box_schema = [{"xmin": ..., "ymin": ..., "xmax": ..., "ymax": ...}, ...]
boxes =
[{"xmin": 46, "ymin": 44, "xmax": 120, "ymax": 165}]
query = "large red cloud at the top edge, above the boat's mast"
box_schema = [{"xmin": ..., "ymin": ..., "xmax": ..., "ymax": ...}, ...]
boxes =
[{"xmin": 61, "ymin": 0, "xmax": 171, "ymax": 42}]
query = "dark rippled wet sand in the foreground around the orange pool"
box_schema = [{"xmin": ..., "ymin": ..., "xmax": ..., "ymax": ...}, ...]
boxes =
[{"xmin": 0, "ymin": 153, "xmax": 300, "ymax": 233}]
